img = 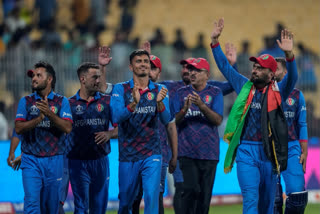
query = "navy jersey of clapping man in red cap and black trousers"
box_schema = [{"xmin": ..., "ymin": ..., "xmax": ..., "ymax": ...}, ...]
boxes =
[{"xmin": 173, "ymin": 84, "xmax": 223, "ymax": 160}]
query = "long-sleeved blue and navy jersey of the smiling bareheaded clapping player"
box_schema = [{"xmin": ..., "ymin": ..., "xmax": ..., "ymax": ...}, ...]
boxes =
[{"xmin": 111, "ymin": 79, "xmax": 171, "ymax": 161}]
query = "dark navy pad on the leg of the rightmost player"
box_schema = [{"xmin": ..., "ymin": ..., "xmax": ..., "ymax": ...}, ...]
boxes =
[{"xmin": 285, "ymin": 191, "xmax": 308, "ymax": 214}]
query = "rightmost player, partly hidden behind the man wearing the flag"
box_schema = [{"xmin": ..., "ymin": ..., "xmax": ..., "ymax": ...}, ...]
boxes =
[{"xmin": 275, "ymin": 58, "xmax": 308, "ymax": 214}]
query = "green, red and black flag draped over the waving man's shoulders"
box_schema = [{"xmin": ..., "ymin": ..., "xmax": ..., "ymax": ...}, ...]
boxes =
[{"xmin": 223, "ymin": 81, "xmax": 288, "ymax": 173}]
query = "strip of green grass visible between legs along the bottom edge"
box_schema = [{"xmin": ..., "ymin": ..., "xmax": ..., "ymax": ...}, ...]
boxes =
[{"xmin": 68, "ymin": 204, "xmax": 320, "ymax": 214}]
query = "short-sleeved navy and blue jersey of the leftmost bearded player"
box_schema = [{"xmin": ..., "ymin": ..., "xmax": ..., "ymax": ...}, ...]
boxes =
[{"xmin": 16, "ymin": 91, "xmax": 72, "ymax": 157}]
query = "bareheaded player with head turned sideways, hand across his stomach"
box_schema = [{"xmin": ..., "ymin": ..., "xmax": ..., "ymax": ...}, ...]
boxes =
[{"xmin": 67, "ymin": 62, "xmax": 115, "ymax": 214}]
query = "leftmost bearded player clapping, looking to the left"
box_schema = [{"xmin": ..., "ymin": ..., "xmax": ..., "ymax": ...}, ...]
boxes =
[{"xmin": 13, "ymin": 61, "xmax": 72, "ymax": 213}]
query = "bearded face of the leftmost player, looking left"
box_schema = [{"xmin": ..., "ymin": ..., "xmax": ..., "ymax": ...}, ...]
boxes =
[{"xmin": 32, "ymin": 67, "xmax": 52, "ymax": 91}]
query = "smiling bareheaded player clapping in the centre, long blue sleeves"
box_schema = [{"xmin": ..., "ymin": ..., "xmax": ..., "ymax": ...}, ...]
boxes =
[{"xmin": 111, "ymin": 50, "xmax": 171, "ymax": 214}]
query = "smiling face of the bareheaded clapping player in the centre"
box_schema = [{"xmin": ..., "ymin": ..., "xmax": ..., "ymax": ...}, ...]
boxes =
[{"xmin": 129, "ymin": 54, "xmax": 150, "ymax": 77}]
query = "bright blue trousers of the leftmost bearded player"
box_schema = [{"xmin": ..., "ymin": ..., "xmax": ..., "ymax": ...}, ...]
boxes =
[{"xmin": 21, "ymin": 154, "xmax": 63, "ymax": 214}]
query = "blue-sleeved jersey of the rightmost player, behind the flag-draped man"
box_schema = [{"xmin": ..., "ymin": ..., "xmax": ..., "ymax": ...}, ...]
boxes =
[{"xmin": 283, "ymin": 88, "xmax": 308, "ymax": 142}]
